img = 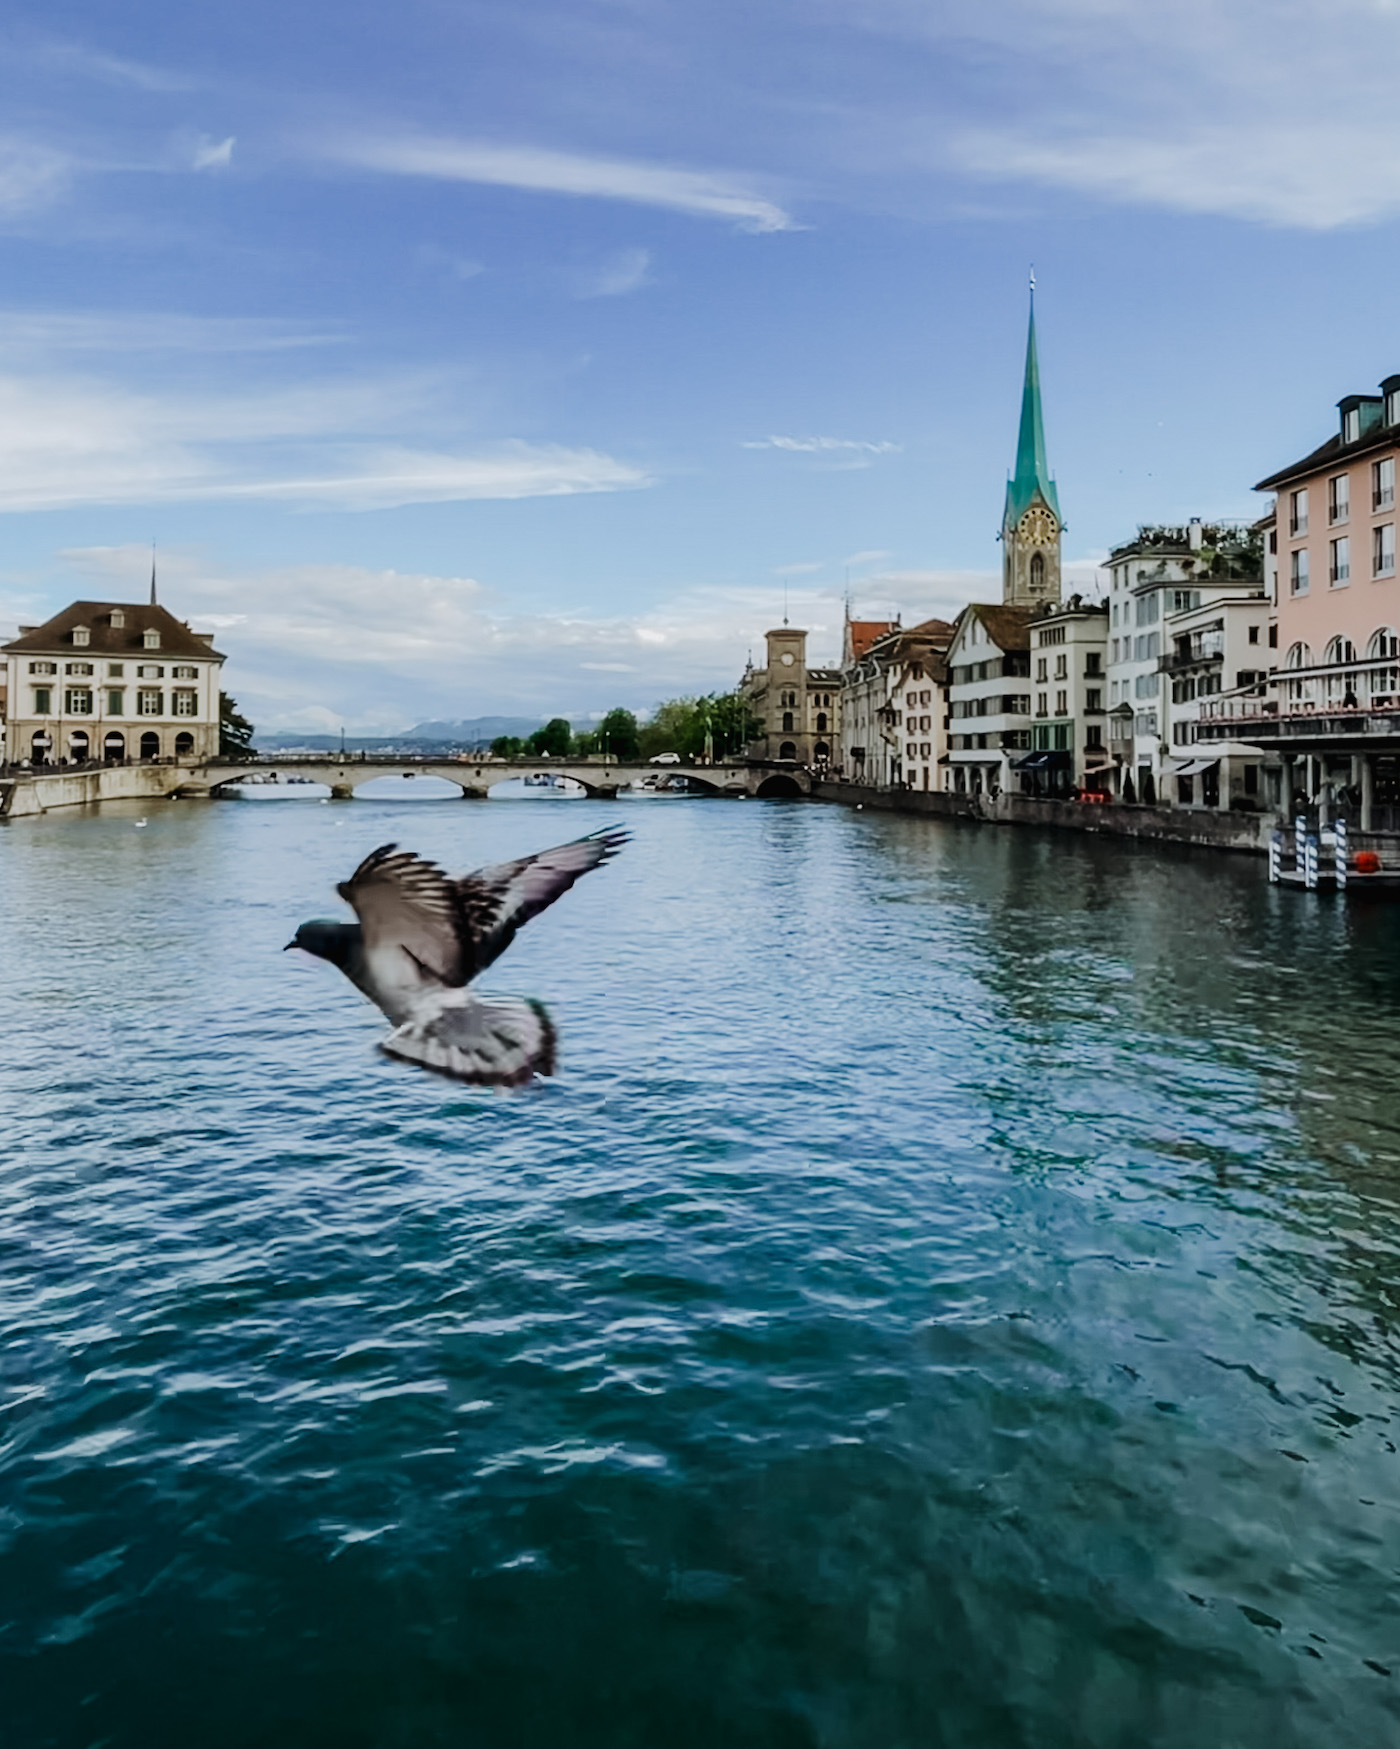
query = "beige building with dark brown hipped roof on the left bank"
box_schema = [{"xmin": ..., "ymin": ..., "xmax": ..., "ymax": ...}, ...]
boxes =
[{"xmin": 0, "ymin": 602, "xmax": 224, "ymax": 764}]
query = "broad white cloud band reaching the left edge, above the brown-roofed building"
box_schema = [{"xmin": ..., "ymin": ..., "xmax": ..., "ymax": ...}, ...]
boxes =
[{"xmin": 0, "ymin": 376, "xmax": 649, "ymax": 511}]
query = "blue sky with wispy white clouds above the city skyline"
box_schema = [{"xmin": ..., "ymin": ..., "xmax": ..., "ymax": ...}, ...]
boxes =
[{"xmin": 0, "ymin": 0, "xmax": 1400, "ymax": 729}]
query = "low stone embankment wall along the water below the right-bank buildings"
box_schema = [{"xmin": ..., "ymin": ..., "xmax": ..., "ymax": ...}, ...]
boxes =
[{"xmin": 812, "ymin": 784, "xmax": 1274, "ymax": 855}]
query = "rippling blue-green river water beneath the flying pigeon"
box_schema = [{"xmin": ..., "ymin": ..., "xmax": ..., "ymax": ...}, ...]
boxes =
[{"xmin": 0, "ymin": 801, "xmax": 1400, "ymax": 1749}]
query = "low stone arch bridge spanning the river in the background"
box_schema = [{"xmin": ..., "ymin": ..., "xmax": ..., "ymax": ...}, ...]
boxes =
[{"xmin": 179, "ymin": 754, "xmax": 812, "ymax": 799}]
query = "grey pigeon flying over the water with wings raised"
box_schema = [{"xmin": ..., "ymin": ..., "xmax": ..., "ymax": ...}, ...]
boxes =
[{"xmin": 287, "ymin": 827, "xmax": 628, "ymax": 1086}]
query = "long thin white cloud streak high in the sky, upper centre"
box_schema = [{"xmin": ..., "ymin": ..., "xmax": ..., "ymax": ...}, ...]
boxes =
[{"xmin": 327, "ymin": 138, "xmax": 795, "ymax": 231}]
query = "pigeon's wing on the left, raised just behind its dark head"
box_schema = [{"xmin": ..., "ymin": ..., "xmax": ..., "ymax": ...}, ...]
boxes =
[{"xmin": 336, "ymin": 845, "xmax": 471, "ymax": 1020}]
